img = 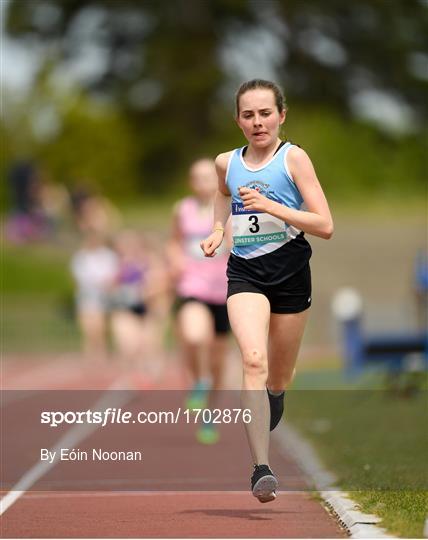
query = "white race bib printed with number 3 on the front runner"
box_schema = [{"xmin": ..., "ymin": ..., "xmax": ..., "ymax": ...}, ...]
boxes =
[{"xmin": 232, "ymin": 203, "xmax": 287, "ymax": 246}]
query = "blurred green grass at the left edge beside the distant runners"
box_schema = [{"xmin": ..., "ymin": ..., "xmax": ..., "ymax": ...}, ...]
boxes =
[{"xmin": 1, "ymin": 245, "xmax": 79, "ymax": 353}]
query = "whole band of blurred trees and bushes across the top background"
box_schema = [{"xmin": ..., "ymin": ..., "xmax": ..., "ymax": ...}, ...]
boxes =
[{"xmin": 4, "ymin": 0, "xmax": 428, "ymax": 202}]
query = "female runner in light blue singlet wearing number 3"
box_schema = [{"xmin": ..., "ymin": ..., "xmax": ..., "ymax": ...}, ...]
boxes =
[{"xmin": 201, "ymin": 79, "xmax": 333, "ymax": 502}]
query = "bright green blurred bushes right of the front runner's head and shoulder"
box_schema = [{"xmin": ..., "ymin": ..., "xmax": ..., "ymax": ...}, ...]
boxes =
[{"xmin": 285, "ymin": 107, "xmax": 427, "ymax": 200}]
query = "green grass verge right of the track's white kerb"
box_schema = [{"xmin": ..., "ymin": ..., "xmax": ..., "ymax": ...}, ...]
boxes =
[{"xmin": 287, "ymin": 378, "xmax": 428, "ymax": 538}]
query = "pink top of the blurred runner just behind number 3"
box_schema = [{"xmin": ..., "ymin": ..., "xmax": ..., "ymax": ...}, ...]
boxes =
[{"xmin": 177, "ymin": 197, "xmax": 229, "ymax": 304}]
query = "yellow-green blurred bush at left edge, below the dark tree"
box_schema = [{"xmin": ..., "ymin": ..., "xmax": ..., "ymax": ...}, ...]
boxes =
[{"xmin": 1, "ymin": 70, "xmax": 140, "ymax": 206}]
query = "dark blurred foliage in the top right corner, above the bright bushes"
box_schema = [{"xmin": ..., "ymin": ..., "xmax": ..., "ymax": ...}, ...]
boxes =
[{"xmin": 277, "ymin": 0, "xmax": 428, "ymax": 113}]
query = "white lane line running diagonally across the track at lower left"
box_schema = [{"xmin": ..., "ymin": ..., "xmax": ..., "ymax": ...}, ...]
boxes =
[{"xmin": 0, "ymin": 377, "xmax": 133, "ymax": 516}]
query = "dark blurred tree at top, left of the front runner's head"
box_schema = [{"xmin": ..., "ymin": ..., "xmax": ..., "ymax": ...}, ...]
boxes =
[{"xmin": 7, "ymin": 0, "xmax": 254, "ymax": 191}]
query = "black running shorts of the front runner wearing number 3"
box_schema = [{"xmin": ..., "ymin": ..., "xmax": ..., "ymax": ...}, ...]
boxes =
[{"xmin": 227, "ymin": 263, "xmax": 312, "ymax": 313}]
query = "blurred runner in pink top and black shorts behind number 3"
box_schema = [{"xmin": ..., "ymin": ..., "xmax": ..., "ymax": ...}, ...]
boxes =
[{"xmin": 168, "ymin": 159, "xmax": 234, "ymax": 444}]
